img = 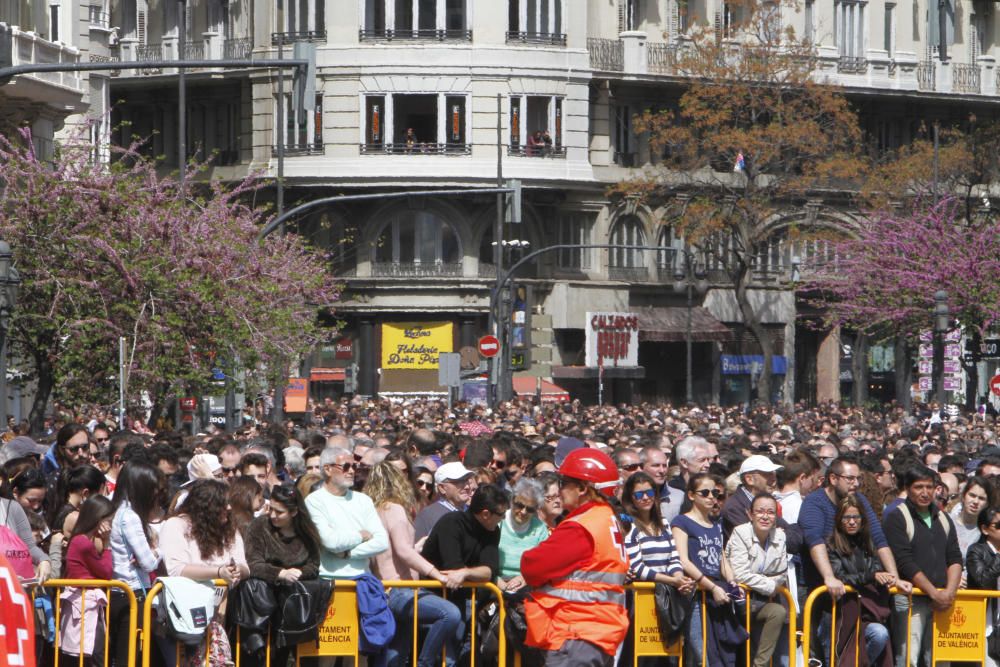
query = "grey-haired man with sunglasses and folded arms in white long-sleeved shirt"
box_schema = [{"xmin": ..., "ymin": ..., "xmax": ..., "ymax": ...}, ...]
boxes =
[{"xmin": 306, "ymin": 447, "xmax": 389, "ymax": 579}]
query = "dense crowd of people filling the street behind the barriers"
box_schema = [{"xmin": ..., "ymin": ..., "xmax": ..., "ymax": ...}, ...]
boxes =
[{"xmin": 0, "ymin": 399, "xmax": 1000, "ymax": 667}]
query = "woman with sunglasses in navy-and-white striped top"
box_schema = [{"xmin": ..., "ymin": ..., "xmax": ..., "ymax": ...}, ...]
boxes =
[{"xmin": 622, "ymin": 472, "xmax": 694, "ymax": 594}]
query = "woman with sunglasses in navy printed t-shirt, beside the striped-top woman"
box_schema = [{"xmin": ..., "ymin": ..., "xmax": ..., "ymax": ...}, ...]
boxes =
[{"xmin": 671, "ymin": 473, "xmax": 733, "ymax": 667}]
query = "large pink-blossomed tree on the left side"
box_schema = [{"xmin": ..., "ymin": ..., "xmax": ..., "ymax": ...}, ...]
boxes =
[{"xmin": 0, "ymin": 136, "xmax": 339, "ymax": 425}]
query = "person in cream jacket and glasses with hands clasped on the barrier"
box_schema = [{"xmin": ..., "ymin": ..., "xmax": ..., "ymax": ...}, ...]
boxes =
[{"xmin": 726, "ymin": 492, "xmax": 788, "ymax": 667}]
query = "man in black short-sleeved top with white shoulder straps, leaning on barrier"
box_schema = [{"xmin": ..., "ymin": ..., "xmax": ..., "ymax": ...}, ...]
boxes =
[{"xmin": 883, "ymin": 466, "xmax": 962, "ymax": 667}]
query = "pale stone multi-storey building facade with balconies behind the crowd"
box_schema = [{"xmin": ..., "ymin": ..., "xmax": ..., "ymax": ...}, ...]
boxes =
[{"xmin": 99, "ymin": 0, "xmax": 997, "ymax": 403}]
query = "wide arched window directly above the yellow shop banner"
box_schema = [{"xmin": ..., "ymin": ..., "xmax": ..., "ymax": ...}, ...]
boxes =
[{"xmin": 373, "ymin": 211, "xmax": 462, "ymax": 276}]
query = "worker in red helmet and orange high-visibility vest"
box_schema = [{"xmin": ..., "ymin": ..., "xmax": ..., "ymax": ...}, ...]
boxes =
[{"xmin": 521, "ymin": 448, "xmax": 628, "ymax": 667}]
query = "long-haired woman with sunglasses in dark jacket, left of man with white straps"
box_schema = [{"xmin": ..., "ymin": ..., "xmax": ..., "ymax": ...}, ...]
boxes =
[{"xmin": 819, "ymin": 495, "xmax": 896, "ymax": 667}]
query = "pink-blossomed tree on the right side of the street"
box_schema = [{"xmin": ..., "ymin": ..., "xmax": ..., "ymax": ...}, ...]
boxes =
[{"xmin": 806, "ymin": 198, "xmax": 1000, "ymax": 408}]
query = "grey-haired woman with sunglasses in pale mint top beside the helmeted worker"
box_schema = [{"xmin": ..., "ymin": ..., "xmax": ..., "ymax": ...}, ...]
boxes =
[{"xmin": 497, "ymin": 478, "xmax": 549, "ymax": 593}]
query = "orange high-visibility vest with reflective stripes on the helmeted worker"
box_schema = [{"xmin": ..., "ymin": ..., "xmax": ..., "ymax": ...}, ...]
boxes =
[{"xmin": 524, "ymin": 503, "xmax": 628, "ymax": 655}]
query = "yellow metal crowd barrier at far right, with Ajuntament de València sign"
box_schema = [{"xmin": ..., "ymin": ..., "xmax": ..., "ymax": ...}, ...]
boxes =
[{"xmin": 802, "ymin": 586, "xmax": 1000, "ymax": 667}]
